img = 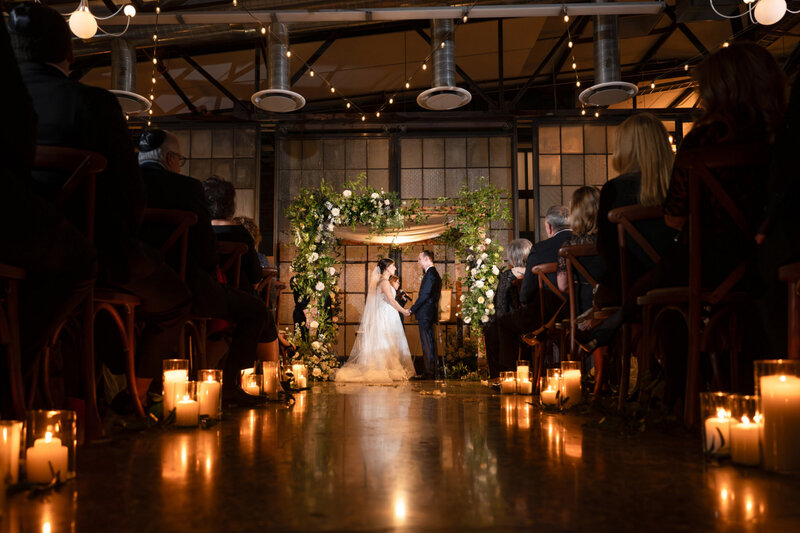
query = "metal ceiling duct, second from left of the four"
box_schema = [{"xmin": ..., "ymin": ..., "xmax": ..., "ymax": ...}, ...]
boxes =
[{"xmin": 250, "ymin": 22, "xmax": 306, "ymax": 113}]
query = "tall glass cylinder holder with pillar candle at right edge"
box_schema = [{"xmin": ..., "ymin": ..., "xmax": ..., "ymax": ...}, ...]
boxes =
[{"xmin": 754, "ymin": 359, "xmax": 800, "ymax": 473}]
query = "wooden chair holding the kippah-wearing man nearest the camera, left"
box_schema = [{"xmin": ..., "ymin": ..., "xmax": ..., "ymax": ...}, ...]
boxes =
[{"xmin": 33, "ymin": 145, "xmax": 119, "ymax": 440}]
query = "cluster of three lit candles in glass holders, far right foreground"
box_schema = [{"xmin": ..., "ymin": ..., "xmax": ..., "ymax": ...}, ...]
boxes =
[{"xmin": 700, "ymin": 359, "xmax": 800, "ymax": 472}]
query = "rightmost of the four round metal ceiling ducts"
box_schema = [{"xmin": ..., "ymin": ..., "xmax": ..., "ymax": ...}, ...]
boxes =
[{"xmin": 578, "ymin": 1, "xmax": 639, "ymax": 106}]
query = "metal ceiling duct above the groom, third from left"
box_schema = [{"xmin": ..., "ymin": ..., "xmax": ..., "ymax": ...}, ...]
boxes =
[{"xmin": 417, "ymin": 19, "xmax": 472, "ymax": 111}]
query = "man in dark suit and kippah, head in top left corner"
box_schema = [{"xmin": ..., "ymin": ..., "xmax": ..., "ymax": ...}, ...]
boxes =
[{"xmin": 9, "ymin": 4, "xmax": 191, "ymax": 406}]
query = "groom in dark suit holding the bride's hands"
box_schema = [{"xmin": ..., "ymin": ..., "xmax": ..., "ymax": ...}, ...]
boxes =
[{"xmin": 410, "ymin": 250, "xmax": 442, "ymax": 379}]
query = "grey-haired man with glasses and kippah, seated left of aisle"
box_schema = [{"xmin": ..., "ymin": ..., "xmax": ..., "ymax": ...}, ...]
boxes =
[{"xmin": 139, "ymin": 129, "xmax": 278, "ymax": 396}]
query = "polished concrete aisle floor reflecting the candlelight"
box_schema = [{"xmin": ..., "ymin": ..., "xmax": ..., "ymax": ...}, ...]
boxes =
[{"xmin": 0, "ymin": 382, "xmax": 800, "ymax": 533}]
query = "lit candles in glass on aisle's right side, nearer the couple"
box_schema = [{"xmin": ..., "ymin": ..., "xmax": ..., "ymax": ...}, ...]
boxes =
[{"xmin": 500, "ymin": 361, "xmax": 581, "ymax": 408}]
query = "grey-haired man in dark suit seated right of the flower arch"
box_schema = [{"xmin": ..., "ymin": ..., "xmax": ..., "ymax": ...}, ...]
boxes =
[{"xmin": 485, "ymin": 205, "xmax": 572, "ymax": 378}]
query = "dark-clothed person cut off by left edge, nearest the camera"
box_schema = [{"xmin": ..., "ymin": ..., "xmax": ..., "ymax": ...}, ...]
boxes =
[{"xmin": 0, "ymin": 12, "xmax": 97, "ymax": 393}]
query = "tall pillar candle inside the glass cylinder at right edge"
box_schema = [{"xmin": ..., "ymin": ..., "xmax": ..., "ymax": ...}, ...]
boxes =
[{"xmin": 761, "ymin": 375, "xmax": 800, "ymax": 472}]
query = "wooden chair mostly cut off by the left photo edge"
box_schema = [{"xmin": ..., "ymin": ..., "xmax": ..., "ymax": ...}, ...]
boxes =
[{"xmin": 0, "ymin": 264, "xmax": 26, "ymax": 420}]
